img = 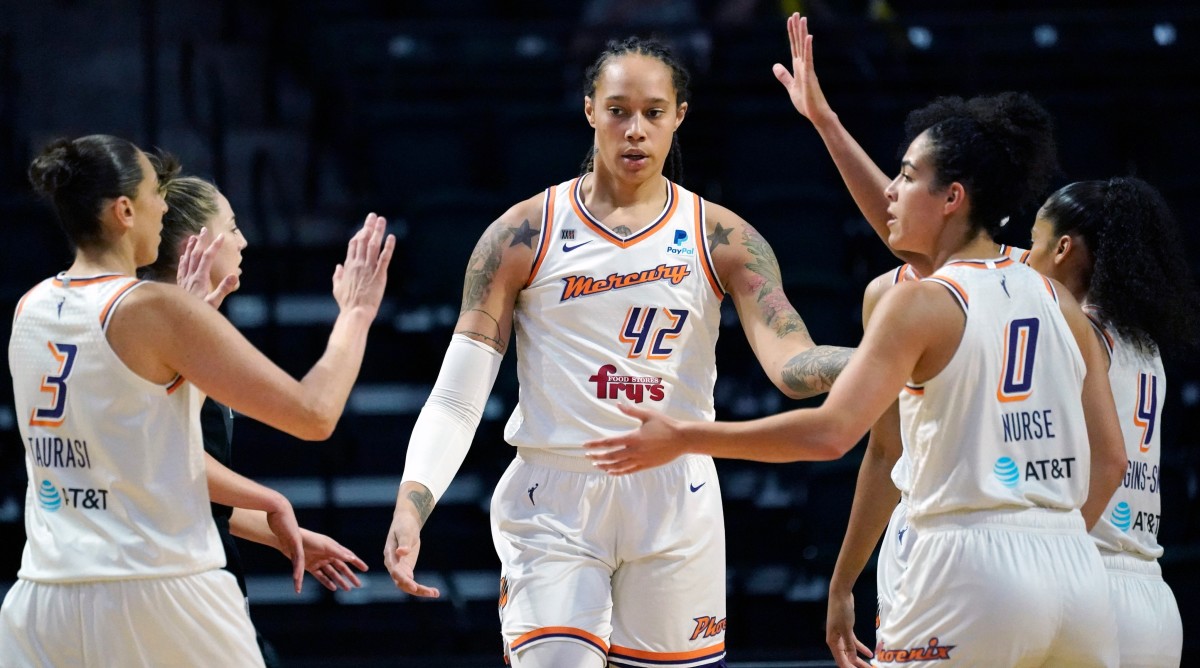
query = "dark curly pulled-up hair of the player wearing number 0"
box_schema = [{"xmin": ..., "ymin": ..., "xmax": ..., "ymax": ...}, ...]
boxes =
[{"xmin": 900, "ymin": 92, "xmax": 1058, "ymax": 237}]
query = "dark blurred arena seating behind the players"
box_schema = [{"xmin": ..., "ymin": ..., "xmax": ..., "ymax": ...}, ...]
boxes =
[{"xmin": 0, "ymin": 0, "xmax": 1200, "ymax": 666}]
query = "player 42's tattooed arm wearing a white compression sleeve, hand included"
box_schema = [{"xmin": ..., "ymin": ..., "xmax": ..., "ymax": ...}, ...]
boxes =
[{"xmin": 383, "ymin": 195, "xmax": 542, "ymax": 597}]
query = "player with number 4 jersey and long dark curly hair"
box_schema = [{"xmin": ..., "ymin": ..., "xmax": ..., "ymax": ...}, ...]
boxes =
[{"xmin": 1030, "ymin": 177, "xmax": 1200, "ymax": 667}]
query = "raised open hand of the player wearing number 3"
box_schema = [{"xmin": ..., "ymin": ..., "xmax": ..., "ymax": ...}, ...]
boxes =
[{"xmin": 334, "ymin": 213, "xmax": 396, "ymax": 317}]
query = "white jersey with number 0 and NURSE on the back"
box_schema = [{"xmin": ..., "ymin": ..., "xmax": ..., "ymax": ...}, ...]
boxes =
[{"xmin": 900, "ymin": 258, "xmax": 1091, "ymax": 518}]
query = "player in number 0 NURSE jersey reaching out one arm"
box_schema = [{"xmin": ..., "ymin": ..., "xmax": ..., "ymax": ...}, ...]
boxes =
[{"xmin": 588, "ymin": 94, "xmax": 1124, "ymax": 666}]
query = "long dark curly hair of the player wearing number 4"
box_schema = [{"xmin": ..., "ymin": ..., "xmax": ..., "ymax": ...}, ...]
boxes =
[{"xmin": 1039, "ymin": 177, "xmax": 1200, "ymax": 353}]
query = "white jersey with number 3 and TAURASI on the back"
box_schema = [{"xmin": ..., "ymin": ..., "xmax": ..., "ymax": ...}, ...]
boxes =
[{"xmin": 8, "ymin": 273, "xmax": 224, "ymax": 583}]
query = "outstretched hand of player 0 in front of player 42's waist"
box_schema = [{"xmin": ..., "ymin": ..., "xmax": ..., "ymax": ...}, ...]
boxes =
[{"xmin": 583, "ymin": 404, "xmax": 685, "ymax": 475}]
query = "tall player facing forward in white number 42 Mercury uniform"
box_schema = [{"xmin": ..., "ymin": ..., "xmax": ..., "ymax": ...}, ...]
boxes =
[{"xmin": 384, "ymin": 38, "xmax": 848, "ymax": 668}]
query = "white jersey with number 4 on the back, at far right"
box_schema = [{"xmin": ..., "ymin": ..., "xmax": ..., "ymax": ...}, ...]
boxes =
[{"xmin": 1090, "ymin": 314, "xmax": 1166, "ymax": 559}]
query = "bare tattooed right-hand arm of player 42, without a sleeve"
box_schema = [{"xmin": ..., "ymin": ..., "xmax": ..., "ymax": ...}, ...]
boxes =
[{"xmin": 707, "ymin": 203, "xmax": 853, "ymax": 398}]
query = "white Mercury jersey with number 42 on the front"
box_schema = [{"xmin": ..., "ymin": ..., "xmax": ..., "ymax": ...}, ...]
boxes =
[{"xmin": 504, "ymin": 176, "xmax": 724, "ymax": 456}]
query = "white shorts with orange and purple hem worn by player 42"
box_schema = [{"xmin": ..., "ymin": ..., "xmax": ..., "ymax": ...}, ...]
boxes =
[{"xmin": 491, "ymin": 449, "xmax": 725, "ymax": 668}]
